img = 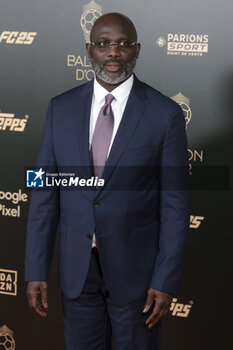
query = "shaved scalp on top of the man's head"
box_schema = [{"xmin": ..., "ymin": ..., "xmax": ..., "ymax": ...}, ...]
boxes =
[{"xmin": 90, "ymin": 12, "xmax": 137, "ymax": 41}]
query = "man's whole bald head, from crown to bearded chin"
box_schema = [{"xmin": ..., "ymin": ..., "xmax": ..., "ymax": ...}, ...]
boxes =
[{"xmin": 86, "ymin": 12, "xmax": 140, "ymax": 91}]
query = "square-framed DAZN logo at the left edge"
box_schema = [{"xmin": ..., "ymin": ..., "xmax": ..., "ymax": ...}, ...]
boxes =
[{"xmin": 0, "ymin": 269, "xmax": 18, "ymax": 296}]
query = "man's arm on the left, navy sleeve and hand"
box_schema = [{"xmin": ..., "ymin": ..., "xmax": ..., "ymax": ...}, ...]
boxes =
[{"xmin": 25, "ymin": 102, "xmax": 59, "ymax": 316}]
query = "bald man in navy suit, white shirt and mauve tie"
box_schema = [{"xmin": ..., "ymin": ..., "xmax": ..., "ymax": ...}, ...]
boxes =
[{"xmin": 25, "ymin": 13, "xmax": 189, "ymax": 350}]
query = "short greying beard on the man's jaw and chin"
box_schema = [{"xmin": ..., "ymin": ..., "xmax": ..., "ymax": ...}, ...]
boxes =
[{"xmin": 90, "ymin": 57, "xmax": 137, "ymax": 85}]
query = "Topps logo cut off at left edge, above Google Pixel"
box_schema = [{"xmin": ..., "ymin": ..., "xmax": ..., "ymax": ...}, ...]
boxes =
[{"xmin": 0, "ymin": 113, "xmax": 29, "ymax": 132}]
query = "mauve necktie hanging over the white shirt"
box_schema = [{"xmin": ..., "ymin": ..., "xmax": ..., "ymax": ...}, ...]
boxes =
[{"xmin": 91, "ymin": 94, "xmax": 114, "ymax": 178}]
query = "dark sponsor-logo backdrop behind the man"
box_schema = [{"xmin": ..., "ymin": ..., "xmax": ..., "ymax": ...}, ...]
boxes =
[{"xmin": 0, "ymin": 0, "xmax": 233, "ymax": 350}]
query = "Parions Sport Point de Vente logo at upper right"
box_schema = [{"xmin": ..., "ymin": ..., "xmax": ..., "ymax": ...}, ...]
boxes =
[{"xmin": 156, "ymin": 33, "xmax": 209, "ymax": 56}]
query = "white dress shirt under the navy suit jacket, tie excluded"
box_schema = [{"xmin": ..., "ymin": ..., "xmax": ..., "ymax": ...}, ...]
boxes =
[{"xmin": 89, "ymin": 75, "xmax": 134, "ymax": 247}]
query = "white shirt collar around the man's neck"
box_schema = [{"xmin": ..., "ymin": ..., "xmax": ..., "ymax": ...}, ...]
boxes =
[{"xmin": 94, "ymin": 74, "xmax": 134, "ymax": 103}]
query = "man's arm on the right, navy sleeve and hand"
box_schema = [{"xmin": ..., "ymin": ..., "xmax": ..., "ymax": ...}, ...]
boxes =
[{"xmin": 143, "ymin": 107, "xmax": 189, "ymax": 329}]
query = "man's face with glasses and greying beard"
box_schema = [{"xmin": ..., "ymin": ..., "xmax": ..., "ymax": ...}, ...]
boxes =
[{"xmin": 87, "ymin": 20, "xmax": 140, "ymax": 85}]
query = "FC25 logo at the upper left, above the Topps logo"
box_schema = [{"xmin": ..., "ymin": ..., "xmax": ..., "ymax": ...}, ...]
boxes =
[{"xmin": 0, "ymin": 30, "xmax": 37, "ymax": 45}]
